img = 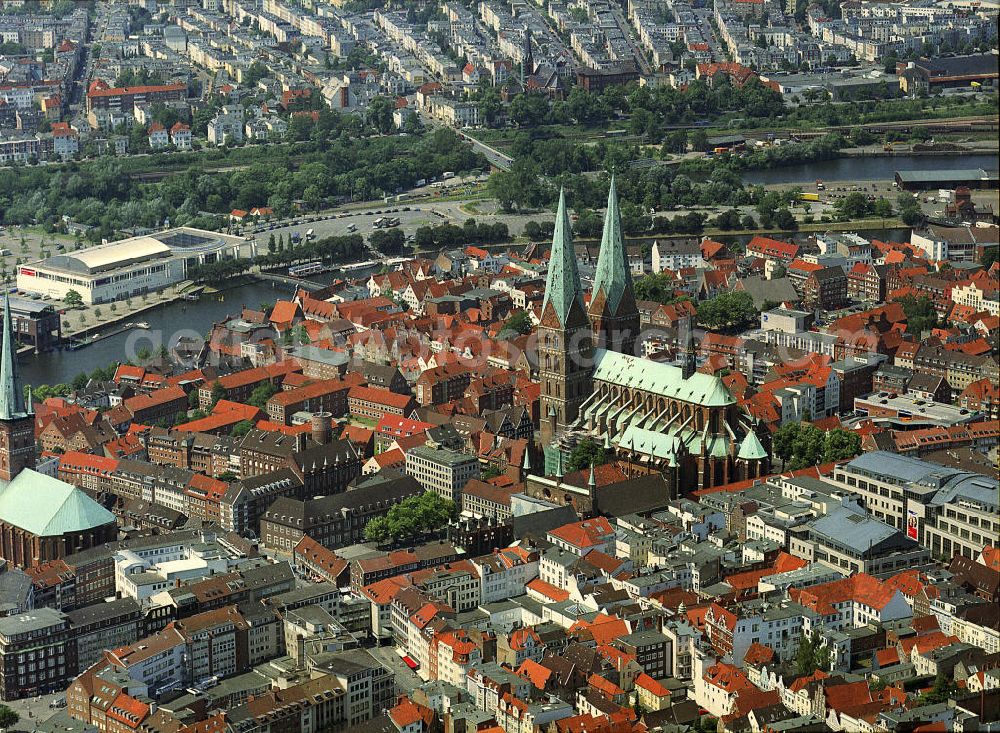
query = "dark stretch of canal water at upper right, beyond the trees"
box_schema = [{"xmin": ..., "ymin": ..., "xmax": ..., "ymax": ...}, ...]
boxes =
[{"xmin": 741, "ymin": 153, "xmax": 998, "ymax": 185}]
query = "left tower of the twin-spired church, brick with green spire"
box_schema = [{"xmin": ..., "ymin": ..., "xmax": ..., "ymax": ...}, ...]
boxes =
[{"xmin": 538, "ymin": 191, "xmax": 593, "ymax": 446}]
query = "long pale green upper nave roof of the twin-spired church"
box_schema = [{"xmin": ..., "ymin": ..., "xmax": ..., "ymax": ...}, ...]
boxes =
[{"xmin": 594, "ymin": 349, "xmax": 736, "ymax": 407}]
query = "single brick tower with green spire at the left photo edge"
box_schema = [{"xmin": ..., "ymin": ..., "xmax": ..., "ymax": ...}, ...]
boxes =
[{"xmin": 0, "ymin": 293, "xmax": 35, "ymax": 481}]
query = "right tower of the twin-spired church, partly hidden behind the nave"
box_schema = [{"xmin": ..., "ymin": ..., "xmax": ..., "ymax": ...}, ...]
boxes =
[{"xmin": 589, "ymin": 177, "xmax": 639, "ymax": 355}]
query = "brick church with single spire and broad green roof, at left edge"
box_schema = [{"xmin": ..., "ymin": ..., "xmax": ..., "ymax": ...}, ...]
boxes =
[{"xmin": 0, "ymin": 296, "xmax": 118, "ymax": 568}]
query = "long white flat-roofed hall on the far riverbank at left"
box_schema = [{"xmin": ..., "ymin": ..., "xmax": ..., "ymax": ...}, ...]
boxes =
[{"xmin": 17, "ymin": 227, "xmax": 256, "ymax": 304}]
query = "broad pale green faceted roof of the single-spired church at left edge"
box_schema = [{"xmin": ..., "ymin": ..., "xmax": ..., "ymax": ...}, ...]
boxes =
[{"xmin": 0, "ymin": 468, "xmax": 115, "ymax": 537}]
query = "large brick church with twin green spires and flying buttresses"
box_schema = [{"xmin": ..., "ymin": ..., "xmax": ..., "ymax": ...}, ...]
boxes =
[{"xmin": 538, "ymin": 179, "xmax": 768, "ymax": 496}]
